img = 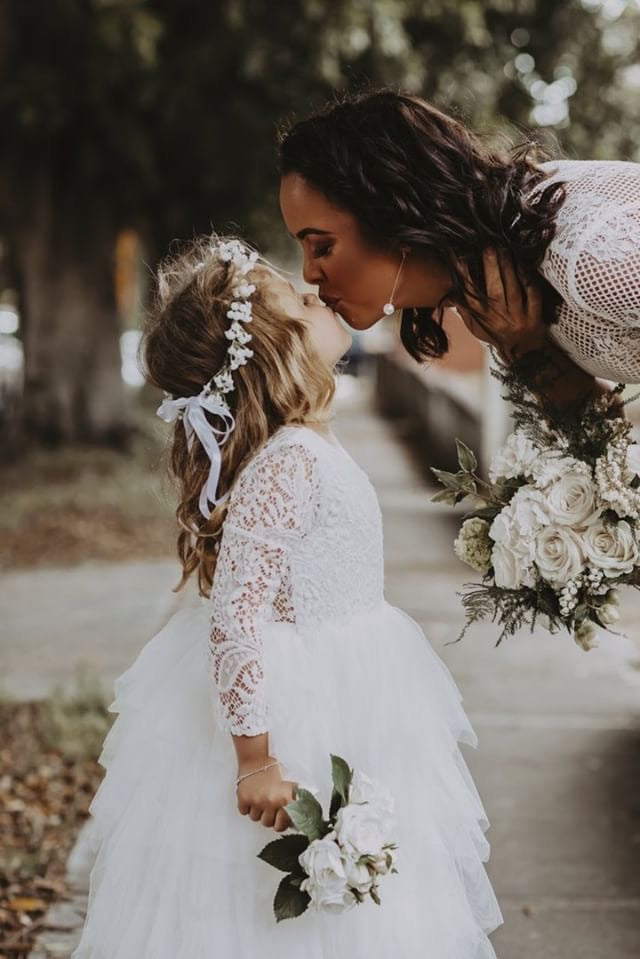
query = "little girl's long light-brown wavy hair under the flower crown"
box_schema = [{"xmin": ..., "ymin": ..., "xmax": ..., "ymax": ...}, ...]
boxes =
[{"xmin": 139, "ymin": 237, "xmax": 335, "ymax": 596}]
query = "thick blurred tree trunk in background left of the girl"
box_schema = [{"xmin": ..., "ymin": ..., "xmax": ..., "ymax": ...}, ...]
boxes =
[{"xmin": 14, "ymin": 172, "xmax": 130, "ymax": 447}]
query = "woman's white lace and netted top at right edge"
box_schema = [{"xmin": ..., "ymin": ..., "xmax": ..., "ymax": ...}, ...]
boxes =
[{"xmin": 532, "ymin": 160, "xmax": 640, "ymax": 383}]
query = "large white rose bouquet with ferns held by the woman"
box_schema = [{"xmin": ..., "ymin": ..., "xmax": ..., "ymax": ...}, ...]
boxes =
[{"xmin": 433, "ymin": 367, "xmax": 640, "ymax": 650}]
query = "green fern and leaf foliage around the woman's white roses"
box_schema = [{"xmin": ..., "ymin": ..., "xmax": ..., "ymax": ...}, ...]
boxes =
[{"xmin": 432, "ymin": 355, "xmax": 640, "ymax": 649}]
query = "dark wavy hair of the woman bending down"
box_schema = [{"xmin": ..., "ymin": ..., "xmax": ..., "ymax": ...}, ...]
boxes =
[{"xmin": 278, "ymin": 89, "xmax": 565, "ymax": 359}]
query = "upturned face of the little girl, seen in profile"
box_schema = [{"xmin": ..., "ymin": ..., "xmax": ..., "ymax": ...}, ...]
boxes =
[{"xmin": 269, "ymin": 273, "xmax": 352, "ymax": 369}]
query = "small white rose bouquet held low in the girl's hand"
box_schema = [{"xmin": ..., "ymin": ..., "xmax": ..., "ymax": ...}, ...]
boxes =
[{"xmin": 258, "ymin": 755, "xmax": 398, "ymax": 922}]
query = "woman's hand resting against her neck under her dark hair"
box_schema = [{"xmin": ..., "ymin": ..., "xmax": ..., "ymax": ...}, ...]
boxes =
[{"xmin": 453, "ymin": 249, "xmax": 547, "ymax": 362}]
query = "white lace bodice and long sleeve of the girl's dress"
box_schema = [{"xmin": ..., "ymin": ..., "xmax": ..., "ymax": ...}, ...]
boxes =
[{"xmin": 208, "ymin": 427, "xmax": 384, "ymax": 736}]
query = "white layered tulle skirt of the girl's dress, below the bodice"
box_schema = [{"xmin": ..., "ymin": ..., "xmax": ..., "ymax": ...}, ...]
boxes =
[{"xmin": 72, "ymin": 601, "xmax": 502, "ymax": 959}]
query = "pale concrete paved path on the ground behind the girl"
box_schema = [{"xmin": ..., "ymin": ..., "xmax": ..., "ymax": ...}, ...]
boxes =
[{"xmin": 0, "ymin": 376, "xmax": 640, "ymax": 959}]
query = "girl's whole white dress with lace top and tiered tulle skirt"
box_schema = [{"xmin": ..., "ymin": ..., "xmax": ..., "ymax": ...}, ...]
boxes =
[{"xmin": 72, "ymin": 427, "xmax": 502, "ymax": 959}]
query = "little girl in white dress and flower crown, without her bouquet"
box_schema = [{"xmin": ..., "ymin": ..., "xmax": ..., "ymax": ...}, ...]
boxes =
[{"xmin": 72, "ymin": 237, "xmax": 502, "ymax": 959}]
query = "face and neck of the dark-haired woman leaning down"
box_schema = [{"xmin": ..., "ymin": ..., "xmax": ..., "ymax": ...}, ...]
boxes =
[{"xmin": 280, "ymin": 173, "xmax": 451, "ymax": 330}]
